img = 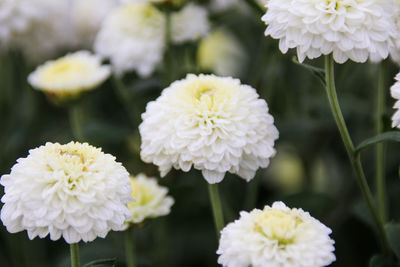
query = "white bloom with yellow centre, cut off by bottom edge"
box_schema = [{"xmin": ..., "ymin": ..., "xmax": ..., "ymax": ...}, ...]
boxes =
[{"xmin": 217, "ymin": 202, "xmax": 336, "ymax": 267}]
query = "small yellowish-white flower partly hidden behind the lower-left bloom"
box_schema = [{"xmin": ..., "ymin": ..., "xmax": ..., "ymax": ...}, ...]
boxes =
[{"xmin": 128, "ymin": 174, "xmax": 174, "ymax": 223}]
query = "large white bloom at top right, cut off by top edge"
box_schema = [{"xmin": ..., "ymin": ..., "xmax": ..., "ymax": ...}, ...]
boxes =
[{"xmin": 262, "ymin": 0, "xmax": 394, "ymax": 63}]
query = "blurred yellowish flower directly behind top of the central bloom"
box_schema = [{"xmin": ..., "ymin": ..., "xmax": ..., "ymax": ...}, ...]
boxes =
[{"xmin": 197, "ymin": 30, "xmax": 246, "ymax": 76}]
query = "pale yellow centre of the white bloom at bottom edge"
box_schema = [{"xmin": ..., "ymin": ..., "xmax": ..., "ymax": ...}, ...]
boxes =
[{"xmin": 254, "ymin": 209, "xmax": 303, "ymax": 245}]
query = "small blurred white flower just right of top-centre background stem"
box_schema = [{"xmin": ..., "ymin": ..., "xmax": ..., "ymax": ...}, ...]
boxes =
[{"xmin": 171, "ymin": 4, "xmax": 210, "ymax": 43}]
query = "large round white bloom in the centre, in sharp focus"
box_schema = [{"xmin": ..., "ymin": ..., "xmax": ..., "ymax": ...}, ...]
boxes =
[{"xmin": 139, "ymin": 74, "xmax": 278, "ymax": 183}]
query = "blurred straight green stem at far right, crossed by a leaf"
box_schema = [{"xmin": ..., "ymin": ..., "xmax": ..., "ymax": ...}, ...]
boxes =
[{"xmin": 376, "ymin": 61, "xmax": 387, "ymax": 223}]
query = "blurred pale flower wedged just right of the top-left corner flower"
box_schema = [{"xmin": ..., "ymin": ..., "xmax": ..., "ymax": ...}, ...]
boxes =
[{"xmin": 71, "ymin": 0, "xmax": 118, "ymax": 48}]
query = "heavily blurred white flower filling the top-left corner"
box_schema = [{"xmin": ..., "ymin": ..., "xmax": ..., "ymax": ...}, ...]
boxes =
[{"xmin": 0, "ymin": 0, "xmax": 73, "ymax": 62}]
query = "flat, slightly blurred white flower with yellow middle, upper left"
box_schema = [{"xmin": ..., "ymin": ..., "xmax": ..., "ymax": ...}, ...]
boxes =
[{"xmin": 28, "ymin": 51, "xmax": 111, "ymax": 98}]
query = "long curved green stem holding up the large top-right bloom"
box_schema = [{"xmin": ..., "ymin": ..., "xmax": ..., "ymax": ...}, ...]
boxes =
[{"xmin": 325, "ymin": 55, "xmax": 390, "ymax": 252}]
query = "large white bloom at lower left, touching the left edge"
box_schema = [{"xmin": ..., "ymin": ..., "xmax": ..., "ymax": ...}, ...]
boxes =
[{"xmin": 0, "ymin": 142, "xmax": 132, "ymax": 244}]
